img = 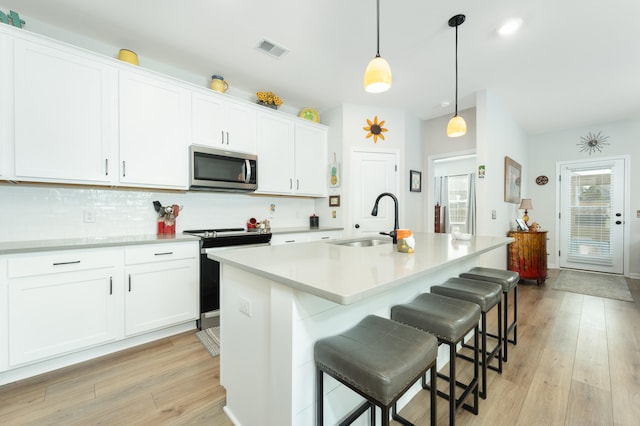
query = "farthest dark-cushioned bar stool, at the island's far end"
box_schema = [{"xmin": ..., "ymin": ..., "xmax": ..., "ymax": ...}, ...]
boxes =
[{"xmin": 460, "ymin": 266, "xmax": 520, "ymax": 362}]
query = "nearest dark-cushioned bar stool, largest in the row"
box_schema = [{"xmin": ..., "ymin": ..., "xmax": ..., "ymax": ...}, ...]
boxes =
[{"xmin": 314, "ymin": 315, "xmax": 438, "ymax": 426}]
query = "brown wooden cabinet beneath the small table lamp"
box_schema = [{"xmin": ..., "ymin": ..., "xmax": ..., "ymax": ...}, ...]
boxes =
[{"xmin": 507, "ymin": 231, "xmax": 547, "ymax": 285}]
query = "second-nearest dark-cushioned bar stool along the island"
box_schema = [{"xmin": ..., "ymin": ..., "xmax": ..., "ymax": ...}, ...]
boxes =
[{"xmin": 391, "ymin": 293, "xmax": 481, "ymax": 425}]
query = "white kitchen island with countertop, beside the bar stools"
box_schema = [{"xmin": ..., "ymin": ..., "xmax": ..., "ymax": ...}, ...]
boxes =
[{"xmin": 209, "ymin": 233, "xmax": 513, "ymax": 426}]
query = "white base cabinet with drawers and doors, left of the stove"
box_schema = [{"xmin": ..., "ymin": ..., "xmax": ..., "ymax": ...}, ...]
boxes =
[{"xmin": 0, "ymin": 241, "xmax": 199, "ymax": 370}]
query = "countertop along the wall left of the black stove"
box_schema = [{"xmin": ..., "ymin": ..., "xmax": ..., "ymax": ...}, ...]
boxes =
[{"xmin": 0, "ymin": 233, "xmax": 200, "ymax": 254}]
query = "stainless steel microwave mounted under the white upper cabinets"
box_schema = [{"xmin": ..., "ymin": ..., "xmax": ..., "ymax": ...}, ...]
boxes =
[{"xmin": 189, "ymin": 145, "xmax": 258, "ymax": 192}]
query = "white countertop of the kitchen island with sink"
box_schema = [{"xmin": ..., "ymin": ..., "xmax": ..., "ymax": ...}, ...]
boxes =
[{"xmin": 209, "ymin": 233, "xmax": 513, "ymax": 305}]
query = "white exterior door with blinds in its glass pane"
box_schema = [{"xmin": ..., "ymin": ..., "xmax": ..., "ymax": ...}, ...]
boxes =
[{"xmin": 559, "ymin": 159, "xmax": 625, "ymax": 274}]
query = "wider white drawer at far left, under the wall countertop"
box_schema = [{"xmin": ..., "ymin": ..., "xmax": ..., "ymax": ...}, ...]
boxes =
[{"xmin": 7, "ymin": 250, "xmax": 121, "ymax": 278}]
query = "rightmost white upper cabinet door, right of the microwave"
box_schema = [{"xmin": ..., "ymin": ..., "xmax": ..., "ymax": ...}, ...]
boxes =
[{"xmin": 294, "ymin": 123, "xmax": 328, "ymax": 197}]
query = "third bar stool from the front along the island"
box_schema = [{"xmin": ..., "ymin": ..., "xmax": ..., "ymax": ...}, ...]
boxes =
[{"xmin": 431, "ymin": 277, "xmax": 503, "ymax": 399}]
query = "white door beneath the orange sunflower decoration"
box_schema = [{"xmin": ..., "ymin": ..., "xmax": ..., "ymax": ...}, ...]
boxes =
[{"xmin": 351, "ymin": 151, "xmax": 400, "ymax": 234}]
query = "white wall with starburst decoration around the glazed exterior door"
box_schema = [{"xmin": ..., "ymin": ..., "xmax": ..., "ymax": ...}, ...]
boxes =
[{"xmin": 527, "ymin": 119, "xmax": 640, "ymax": 278}]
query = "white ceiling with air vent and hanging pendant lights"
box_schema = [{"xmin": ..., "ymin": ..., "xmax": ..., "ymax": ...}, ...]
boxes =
[{"xmin": 0, "ymin": 0, "xmax": 640, "ymax": 134}]
